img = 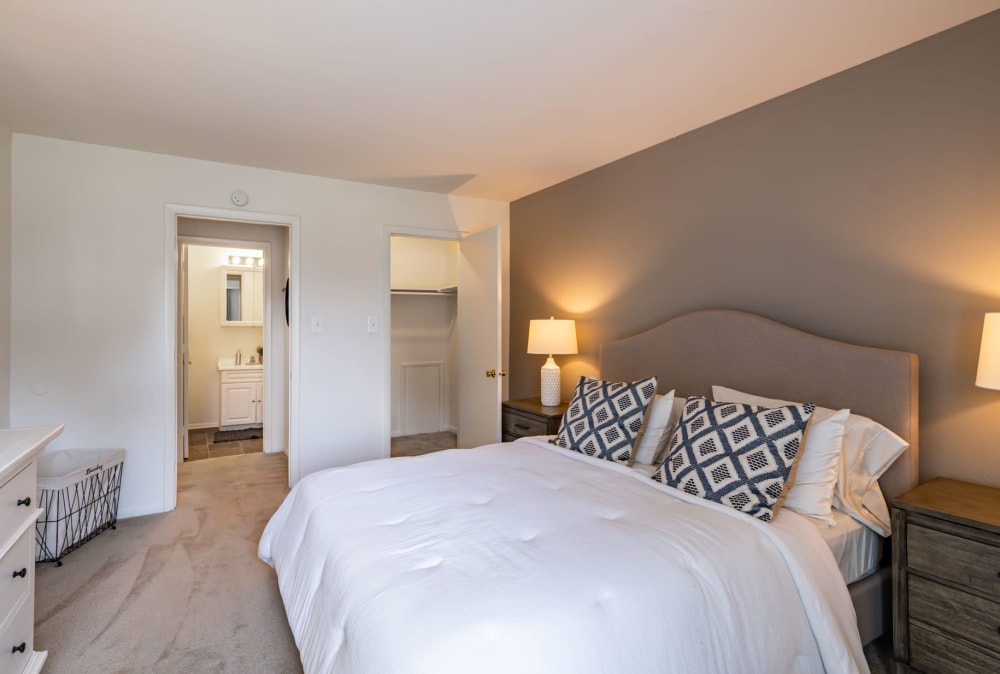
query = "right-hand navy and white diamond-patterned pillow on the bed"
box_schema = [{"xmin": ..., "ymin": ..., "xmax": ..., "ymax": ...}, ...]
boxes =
[{"xmin": 653, "ymin": 396, "xmax": 815, "ymax": 522}]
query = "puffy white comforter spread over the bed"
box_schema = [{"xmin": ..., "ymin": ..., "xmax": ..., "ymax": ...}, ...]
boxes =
[{"xmin": 259, "ymin": 439, "xmax": 867, "ymax": 674}]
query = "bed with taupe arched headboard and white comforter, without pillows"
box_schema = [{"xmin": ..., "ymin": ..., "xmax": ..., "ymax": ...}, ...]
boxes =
[{"xmin": 259, "ymin": 310, "xmax": 918, "ymax": 674}]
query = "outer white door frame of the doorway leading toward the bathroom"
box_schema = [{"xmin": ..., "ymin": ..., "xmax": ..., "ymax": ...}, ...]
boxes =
[{"xmin": 163, "ymin": 203, "xmax": 301, "ymax": 511}]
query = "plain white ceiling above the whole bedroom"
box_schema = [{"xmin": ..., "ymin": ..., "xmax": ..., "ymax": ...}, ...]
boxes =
[{"xmin": 0, "ymin": 0, "xmax": 1000, "ymax": 201}]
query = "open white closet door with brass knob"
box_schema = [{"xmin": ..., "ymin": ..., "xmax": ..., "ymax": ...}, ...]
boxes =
[{"xmin": 457, "ymin": 227, "xmax": 506, "ymax": 447}]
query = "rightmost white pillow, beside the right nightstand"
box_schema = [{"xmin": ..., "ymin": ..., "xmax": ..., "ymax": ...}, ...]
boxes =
[{"xmin": 833, "ymin": 414, "xmax": 910, "ymax": 536}]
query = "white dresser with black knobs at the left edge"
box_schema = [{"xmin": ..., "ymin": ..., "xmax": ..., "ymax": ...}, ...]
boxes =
[{"xmin": 0, "ymin": 426, "xmax": 63, "ymax": 674}]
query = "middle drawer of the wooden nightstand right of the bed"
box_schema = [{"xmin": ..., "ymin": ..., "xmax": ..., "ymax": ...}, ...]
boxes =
[{"xmin": 908, "ymin": 575, "xmax": 1000, "ymax": 651}]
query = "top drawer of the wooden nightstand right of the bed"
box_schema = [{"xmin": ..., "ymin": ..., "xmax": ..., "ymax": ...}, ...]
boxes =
[{"xmin": 906, "ymin": 523, "xmax": 1000, "ymax": 601}]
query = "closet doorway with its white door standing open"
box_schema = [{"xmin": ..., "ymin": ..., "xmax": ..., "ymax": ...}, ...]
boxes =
[{"xmin": 384, "ymin": 226, "xmax": 506, "ymax": 456}]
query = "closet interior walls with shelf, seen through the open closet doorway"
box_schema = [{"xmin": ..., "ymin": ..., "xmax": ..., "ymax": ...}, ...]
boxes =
[{"xmin": 390, "ymin": 236, "xmax": 458, "ymax": 437}]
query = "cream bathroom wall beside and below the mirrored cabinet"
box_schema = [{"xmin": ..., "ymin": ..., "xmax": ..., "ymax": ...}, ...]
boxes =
[{"xmin": 188, "ymin": 246, "xmax": 264, "ymax": 428}]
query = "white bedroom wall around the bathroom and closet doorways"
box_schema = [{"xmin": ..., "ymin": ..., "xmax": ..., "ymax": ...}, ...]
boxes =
[{"xmin": 11, "ymin": 134, "xmax": 509, "ymax": 517}]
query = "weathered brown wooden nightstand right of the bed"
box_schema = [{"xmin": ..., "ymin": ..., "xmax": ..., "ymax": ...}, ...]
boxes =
[{"xmin": 892, "ymin": 478, "xmax": 1000, "ymax": 674}]
